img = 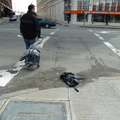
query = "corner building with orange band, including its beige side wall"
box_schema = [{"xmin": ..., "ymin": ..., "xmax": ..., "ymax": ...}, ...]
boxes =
[{"xmin": 37, "ymin": 0, "xmax": 120, "ymax": 24}]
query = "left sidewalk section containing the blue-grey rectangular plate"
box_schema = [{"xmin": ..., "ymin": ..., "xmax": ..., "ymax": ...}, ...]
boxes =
[{"xmin": 0, "ymin": 88, "xmax": 72, "ymax": 120}]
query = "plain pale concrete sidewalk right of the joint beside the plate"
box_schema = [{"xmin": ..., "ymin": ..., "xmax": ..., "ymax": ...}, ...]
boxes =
[{"xmin": 69, "ymin": 77, "xmax": 120, "ymax": 120}]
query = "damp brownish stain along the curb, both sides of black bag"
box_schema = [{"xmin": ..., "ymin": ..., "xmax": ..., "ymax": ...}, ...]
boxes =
[{"xmin": 0, "ymin": 65, "xmax": 120, "ymax": 93}]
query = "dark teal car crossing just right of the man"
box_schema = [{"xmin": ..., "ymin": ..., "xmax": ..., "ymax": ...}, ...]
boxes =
[{"xmin": 38, "ymin": 17, "xmax": 56, "ymax": 28}]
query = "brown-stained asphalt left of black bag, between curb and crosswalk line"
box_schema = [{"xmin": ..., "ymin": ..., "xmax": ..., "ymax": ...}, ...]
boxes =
[{"xmin": 1, "ymin": 67, "xmax": 67, "ymax": 94}]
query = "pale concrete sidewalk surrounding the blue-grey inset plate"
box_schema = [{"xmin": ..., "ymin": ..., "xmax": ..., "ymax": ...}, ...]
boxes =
[{"xmin": 0, "ymin": 77, "xmax": 120, "ymax": 120}]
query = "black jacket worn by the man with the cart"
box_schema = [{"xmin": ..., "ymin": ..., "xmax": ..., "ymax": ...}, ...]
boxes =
[{"xmin": 20, "ymin": 11, "xmax": 41, "ymax": 39}]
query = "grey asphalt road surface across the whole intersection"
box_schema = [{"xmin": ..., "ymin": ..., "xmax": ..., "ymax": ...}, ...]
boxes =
[{"xmin": 0, "ymin": 22, "xmax": 120, "ymax": 94}]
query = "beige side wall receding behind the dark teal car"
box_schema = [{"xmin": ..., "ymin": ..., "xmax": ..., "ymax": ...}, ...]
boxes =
[{"xmin": 37, "ymin": 0, "xmax": 64, "ymax": 22}]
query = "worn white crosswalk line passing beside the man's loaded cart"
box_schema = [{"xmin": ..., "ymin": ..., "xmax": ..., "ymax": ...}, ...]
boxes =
[{"xmin": 0, "ymin": 28, "xmax": 61, "ymax": 87}]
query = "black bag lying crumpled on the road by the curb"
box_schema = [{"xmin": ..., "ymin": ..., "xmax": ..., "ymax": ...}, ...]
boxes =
[{"xmin": 60, "ymin": 72, "xmax": 84, "ymax": 87}]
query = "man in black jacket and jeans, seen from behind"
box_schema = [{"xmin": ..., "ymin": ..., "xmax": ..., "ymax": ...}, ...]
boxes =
[{"xmin": 20, "ymin": 4, "xmax": 41, "ymax": 49}]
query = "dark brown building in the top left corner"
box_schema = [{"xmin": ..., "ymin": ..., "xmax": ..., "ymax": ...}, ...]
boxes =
[{"xmin": 0, "ymin": 0, "xmax": 12, "ymax": 17}]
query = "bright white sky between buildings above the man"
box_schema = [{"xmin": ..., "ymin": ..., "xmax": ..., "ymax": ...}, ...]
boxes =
[{"xmin": 12, "ymin": 0, "xmax": 36, "ymax": 12}]
